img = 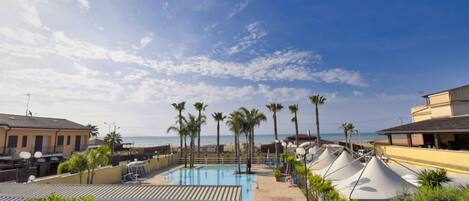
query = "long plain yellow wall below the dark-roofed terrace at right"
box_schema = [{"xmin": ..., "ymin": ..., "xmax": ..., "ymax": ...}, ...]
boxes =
[{"xmin": 375, "ymin": 144, "xmax": 469, "ymax": 172}]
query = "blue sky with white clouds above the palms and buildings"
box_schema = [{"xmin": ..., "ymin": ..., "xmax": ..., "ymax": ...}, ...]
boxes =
[{"xmin": 0, "ymin": 0, "xmax": 469, "ymax": 136}]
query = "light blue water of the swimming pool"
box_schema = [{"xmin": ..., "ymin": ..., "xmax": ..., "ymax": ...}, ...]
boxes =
[{"xmin": 163, "ymin": 166, "xmax": 255, "ymax": 201}]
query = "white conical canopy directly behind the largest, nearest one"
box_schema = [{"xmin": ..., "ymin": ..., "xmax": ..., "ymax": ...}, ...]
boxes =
[{"xmin": 316, "ymin": 151, "xmax": 363, "ymax": 181}]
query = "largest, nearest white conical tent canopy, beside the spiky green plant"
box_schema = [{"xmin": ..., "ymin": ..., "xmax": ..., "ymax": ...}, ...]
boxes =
[{"xmin": 333, "ymin": 157, "xmax": 415, "ymax": 200}]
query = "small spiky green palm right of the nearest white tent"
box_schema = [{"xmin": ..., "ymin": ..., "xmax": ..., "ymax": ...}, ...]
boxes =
[{"xmin": 417, "ymin": 169, "xmax": 451, "ymax": 188}]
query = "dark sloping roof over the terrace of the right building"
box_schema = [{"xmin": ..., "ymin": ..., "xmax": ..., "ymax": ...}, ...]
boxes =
[{"xmin": 378, "ymin": 116, "xmax": 469, "ymax": 134}]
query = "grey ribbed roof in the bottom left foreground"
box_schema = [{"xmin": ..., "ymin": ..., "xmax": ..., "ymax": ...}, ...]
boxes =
[{"xmin": 0, "ymin": 183, "xmax": 242, "ymax": 201}]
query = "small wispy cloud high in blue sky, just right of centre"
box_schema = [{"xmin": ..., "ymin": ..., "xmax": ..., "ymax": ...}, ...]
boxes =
[{"xmin": 227, "ymin": 22, "xmax": 267, "ymax": 55}]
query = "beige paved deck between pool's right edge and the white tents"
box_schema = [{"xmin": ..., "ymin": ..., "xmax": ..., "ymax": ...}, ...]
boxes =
[{"xmin": 253, "ymin": 165, "xmax": 306, "ymax": 201}]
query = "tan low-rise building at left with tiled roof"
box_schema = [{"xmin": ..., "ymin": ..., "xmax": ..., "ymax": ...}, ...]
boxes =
[{"xmin": 0, "ymin": 114, "xmax": 90, "ymax": 159}]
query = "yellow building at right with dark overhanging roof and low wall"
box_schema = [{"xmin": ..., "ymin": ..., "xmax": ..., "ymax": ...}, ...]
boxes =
[{"xmin": 375, "ymin": 85, "xmax": 469, "ymax": 171}]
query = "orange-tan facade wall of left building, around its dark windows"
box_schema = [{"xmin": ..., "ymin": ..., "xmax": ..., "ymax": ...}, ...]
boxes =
[{"xmin": 0, "ymin": 128, "xmax": 89, "ymax": 155}]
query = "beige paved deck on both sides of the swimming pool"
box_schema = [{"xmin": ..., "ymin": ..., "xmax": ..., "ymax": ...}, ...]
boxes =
[{"xmin": 142, "ymin": 165, "xmax": 306, "ymax": 201}]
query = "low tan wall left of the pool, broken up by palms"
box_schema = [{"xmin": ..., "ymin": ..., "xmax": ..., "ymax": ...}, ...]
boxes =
[{"xmin": 33, "ymin": 156, "xmax": 175, "ymax": 184}]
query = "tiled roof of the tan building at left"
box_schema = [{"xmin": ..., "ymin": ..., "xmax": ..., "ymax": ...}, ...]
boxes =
[{"xmin": 0, "ymin": 114, "xmax": 89, "ymax": 130}]
